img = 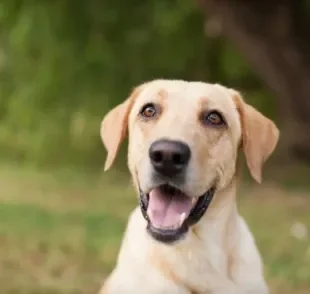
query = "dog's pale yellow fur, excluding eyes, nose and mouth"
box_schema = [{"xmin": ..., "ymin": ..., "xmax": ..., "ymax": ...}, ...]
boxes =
[{"xmin": 100, "ymin": 80, "xmax": 279, "ymax": 294}]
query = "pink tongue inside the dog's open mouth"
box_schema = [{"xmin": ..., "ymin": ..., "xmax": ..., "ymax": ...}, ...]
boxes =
[{"xmin": 147, "ymin": 188, "xmax": 192, "ymax": 228}]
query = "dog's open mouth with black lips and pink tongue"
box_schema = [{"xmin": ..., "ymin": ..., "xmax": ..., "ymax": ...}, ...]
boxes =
[{"xmin": 140, "ymin": 184, "xmax": 214, "ymax": 243}]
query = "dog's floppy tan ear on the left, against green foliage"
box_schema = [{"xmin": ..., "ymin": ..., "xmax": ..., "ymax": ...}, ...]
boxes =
[{"xmin": 100, "ymin": 88, "xmax": 140, "ymax": 171}]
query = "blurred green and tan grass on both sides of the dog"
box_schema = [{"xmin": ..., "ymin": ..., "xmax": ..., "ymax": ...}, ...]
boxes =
[{"xmin": 0, "ymin": 166, "xmax": 310, "ymax": 294}]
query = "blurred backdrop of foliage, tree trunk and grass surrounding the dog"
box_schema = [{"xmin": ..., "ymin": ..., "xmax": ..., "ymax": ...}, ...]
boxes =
[{"xmin": 0, "ymin": 0, "xmax": 310, "ymax": 294}]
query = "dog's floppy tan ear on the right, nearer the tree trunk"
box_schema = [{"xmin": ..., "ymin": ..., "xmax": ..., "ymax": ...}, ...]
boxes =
[{"xmin": 229, "ymin": 89, "xmax": 280, "ymax": 183}]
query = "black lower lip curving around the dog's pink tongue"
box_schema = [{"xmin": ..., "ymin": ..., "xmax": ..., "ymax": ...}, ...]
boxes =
[{"xmin": 140, "ymin": 188, "xmax": 215, "ymax": 244}]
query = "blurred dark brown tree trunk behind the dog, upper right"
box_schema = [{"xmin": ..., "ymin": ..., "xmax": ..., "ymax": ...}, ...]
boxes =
[{"xmin": 197, "ymin": 0, "xmax": 310, "ymax": 162}]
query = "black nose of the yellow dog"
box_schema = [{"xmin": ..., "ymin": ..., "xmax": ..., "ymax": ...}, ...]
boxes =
[{"xmin": 149, "ymin": 139, "xmax": 191, "ymax": 177}]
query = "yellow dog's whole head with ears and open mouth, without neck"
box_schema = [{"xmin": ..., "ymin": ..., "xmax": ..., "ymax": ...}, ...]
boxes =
[{"xmin": 101, "ymin": 80, "xmax": 279, "ymax": 243}]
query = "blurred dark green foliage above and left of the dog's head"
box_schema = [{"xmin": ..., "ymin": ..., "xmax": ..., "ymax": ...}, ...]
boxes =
[{"xmin": 0, "ymin": 0, "xmax": 273, "ymax": 166}]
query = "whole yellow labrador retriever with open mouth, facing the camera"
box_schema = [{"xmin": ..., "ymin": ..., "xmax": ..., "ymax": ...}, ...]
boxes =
[{"xmin": 100, "ymin": 80, "xmax": 279, "ymax": 294}]
